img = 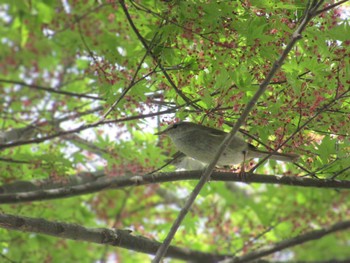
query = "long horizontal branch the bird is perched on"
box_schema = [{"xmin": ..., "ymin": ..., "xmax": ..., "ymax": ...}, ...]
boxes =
[{"xmin": 0, "ymin": 170, "xmax": 350, "ymax": 204}]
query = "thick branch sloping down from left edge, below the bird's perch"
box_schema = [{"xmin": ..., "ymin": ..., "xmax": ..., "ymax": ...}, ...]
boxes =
[{"xmin": 0, "ymin": 213, "xmax": 227, "ymax": 262}]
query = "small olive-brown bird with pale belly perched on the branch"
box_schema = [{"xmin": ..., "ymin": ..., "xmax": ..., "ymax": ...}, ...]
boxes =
[{"xmin": 156, "ymin": 122, "xmax": 299, "ymax": 165}]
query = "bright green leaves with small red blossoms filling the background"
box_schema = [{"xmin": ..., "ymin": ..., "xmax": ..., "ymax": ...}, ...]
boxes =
[{"xmin": 0, "ymin": 0, "xmax": 350, "ymax": 262}]
